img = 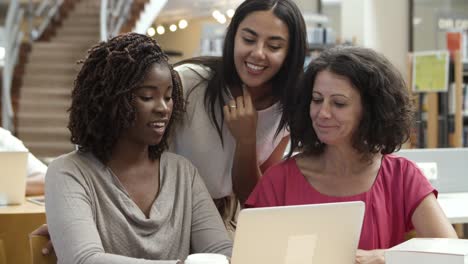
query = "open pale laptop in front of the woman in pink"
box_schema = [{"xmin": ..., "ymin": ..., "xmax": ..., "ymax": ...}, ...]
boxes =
[{"xmin": 231, "ymin": 201, "xmax": 365, "ymax": 264}]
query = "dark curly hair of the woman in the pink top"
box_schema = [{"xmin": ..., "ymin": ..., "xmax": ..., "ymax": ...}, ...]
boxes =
[{"xmin": 286, "ymin": 47, "xmax": 414, "ymax": 159}]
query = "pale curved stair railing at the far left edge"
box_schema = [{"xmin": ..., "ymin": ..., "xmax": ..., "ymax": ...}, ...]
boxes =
[{"xmin": 2, "ymin": 0, "xmax": 24, "ymax": 130}]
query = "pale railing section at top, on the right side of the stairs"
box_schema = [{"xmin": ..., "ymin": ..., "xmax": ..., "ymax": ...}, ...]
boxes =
[{"xmin": 100, "ymin": 0, "xmax": 133, "ymax": 41}]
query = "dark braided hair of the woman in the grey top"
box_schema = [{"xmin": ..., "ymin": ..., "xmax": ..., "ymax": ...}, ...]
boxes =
[{"xmin": 68, "ymin": 33, "xmax": 184, "ymax": 163}]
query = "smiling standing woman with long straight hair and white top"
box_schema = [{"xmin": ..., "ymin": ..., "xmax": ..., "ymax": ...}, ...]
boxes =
[{"xmin": 171, "ymin": 0, "xmax": 307, "ymax": 231}]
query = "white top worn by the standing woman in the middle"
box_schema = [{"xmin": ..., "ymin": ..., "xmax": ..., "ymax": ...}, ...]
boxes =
[{"xmin": 170, "ymin": 64, "xmax": 289, "ymax": 199}]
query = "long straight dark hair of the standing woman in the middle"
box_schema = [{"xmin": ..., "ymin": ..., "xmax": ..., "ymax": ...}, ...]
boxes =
[{"xmin": 177, "ymin": 0, "xmax": 307, "ymax": 142}]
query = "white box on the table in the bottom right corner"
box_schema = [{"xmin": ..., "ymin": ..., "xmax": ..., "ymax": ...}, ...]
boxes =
[{"xmin": 385, "ymin": 238, "xmax": 468, "ymax": 264}]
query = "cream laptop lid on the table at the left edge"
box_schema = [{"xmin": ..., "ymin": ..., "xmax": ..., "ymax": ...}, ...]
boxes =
[{"xmin": 0, "ymin": 151, "xmax": 28, "ymax": 205}]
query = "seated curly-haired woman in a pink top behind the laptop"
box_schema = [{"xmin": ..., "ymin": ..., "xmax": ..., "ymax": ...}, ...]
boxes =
[{"xmin": 246, "ymin": 47, "xmax": 456, "ymax": 263}]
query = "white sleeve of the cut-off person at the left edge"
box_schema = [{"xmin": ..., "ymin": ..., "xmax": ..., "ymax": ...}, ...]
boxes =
[{"xmin": 0, "ymin": 127, "xmax": 47, "ymax": 177}]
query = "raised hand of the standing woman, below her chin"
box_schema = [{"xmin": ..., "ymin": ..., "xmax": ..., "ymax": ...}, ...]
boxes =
[{"xmin": 223, "ymin": 87, "xmax": 257, "ymax": 144}]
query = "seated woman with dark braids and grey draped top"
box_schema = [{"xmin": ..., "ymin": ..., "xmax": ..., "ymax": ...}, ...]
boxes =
[{"xmin": 46, "ymin": 33, "xmax": 232, "ymax": 264}]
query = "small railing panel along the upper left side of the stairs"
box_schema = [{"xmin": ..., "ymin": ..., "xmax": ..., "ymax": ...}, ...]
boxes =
[{"xmin": 29, "ymin": 0, "xmax": 63, "ymax": 41}]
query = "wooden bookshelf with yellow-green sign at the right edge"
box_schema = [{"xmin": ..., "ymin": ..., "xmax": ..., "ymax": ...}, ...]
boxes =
[{"xmin": 408, "ymin": 51, "xmax": 468, "ymax": 148}]
